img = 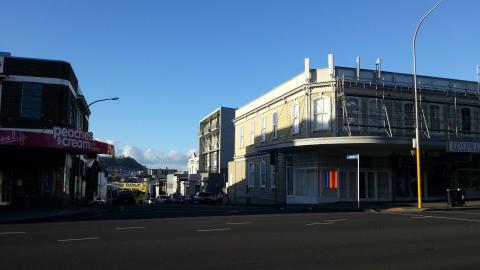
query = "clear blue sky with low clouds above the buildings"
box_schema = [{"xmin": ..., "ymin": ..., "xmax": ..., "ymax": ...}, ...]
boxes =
[{"xmin": 0, "ymin": 0, "xmax": 480, "ymax": 168}]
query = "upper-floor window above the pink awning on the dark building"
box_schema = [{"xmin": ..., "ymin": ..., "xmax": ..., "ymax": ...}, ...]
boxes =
[{"xmin": 20, "ymin": 83, "xmax": 43, "ymax": 119}]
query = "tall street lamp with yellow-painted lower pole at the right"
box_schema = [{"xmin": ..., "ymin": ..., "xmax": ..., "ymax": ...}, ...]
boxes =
[{"xmin": 413, "ymin": 0, "xmax": 443, "ymax": 208}]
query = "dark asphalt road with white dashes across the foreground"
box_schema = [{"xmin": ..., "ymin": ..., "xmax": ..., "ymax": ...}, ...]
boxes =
[{"xmin": 0, "ymin": 206, "xmax": 480, "ymax": 270}]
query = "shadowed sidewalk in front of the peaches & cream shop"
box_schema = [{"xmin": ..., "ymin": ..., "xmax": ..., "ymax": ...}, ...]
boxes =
[{"xmin": 0, "ymin": 206, "xmax": 106, "ymax": 224}]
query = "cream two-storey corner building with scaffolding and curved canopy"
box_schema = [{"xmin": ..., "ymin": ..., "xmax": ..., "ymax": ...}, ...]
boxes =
[{"xmin": 228, "ymin": 55, "xmax": 480, "ymax": 204}]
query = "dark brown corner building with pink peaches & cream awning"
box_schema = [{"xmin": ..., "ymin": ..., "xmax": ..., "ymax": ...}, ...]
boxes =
[{"xmin": 0, "ymin": 53, "xmax": 113, "ymax": 207}]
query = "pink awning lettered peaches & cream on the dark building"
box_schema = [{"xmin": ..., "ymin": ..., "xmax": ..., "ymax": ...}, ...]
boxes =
[{"xmin": 0, "ymin": 127, "xmax": 115, "ymax": 156}]
